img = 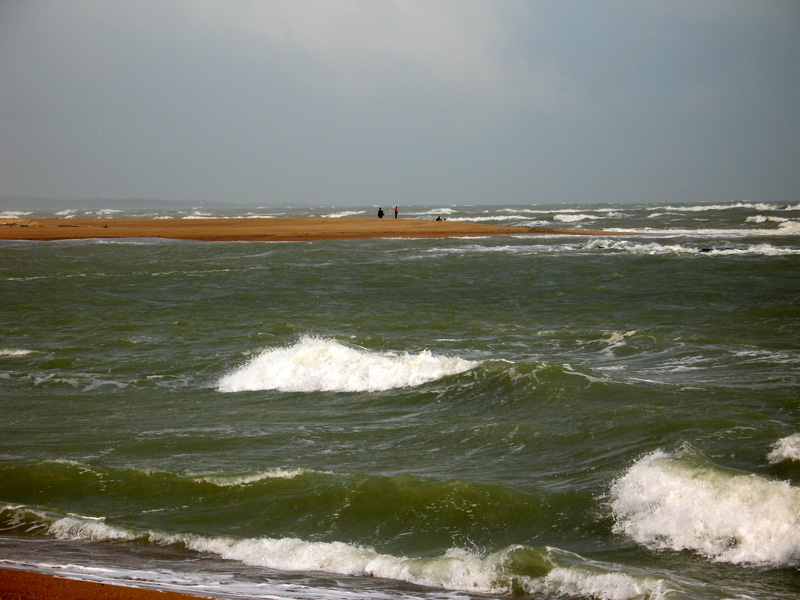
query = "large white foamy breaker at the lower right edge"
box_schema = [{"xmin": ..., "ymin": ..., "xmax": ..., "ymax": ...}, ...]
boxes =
[{"xmin": 611, "ymin": 448, "xmax": 800, "ymax": 567}]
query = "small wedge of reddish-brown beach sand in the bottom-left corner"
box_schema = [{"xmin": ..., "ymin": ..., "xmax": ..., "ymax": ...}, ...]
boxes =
[{"xmin": 0, "ymin": 569, "xmax": 217, "ymax": 600}]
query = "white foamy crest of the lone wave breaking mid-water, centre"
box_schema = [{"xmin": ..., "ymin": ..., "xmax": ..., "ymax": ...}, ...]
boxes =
[{"xmin": 217, "ymin": 336, "xmax": 478, "ymax": 392}]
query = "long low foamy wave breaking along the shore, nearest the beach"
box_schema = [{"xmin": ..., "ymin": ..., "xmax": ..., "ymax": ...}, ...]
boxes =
[{"xmin": 0, "ymin": 505, "xmax": 667, "ymax": 600}]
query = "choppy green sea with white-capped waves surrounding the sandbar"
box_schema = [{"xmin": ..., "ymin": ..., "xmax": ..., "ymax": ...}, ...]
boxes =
[{"xmin": 0, "ymin": 202, "xmax": 800, "ymax": 600}]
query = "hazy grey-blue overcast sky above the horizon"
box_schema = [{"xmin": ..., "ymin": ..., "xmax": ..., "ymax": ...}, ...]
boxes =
[{"xmin": 0, "ymin": 0, "xmax": 800, "ymax": 205}]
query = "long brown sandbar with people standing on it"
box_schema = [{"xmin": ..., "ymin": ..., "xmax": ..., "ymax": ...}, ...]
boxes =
[{"xmin": 0, "ymin": 217, "xmax": 628, "ymax": 242}]
